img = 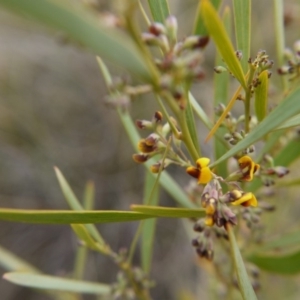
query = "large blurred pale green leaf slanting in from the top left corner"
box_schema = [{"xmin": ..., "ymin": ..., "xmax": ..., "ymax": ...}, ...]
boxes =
[{"xmin": 0, "ymin": 0, "xmax": 152, "ymax": 82}]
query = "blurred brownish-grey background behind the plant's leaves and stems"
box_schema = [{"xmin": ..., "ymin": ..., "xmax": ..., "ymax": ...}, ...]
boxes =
[{"xmin": 0, "ymin": 0, "xmax": 300, "ymax": 300}]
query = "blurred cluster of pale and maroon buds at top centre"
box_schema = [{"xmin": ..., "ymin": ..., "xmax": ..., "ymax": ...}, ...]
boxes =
[{"xmin": 142, "ymin": 16, "xmax": 209, "ymax": 109}]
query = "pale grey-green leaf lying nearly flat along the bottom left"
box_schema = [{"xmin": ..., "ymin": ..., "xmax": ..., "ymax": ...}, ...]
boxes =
[{"xmin": 3, "ymin": 272, "xmax": 111, "ymax": 295}]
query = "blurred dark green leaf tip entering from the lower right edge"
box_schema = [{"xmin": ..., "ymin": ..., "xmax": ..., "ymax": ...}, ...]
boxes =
[{"xmin": 248, "ymin": 251, "xmax": 300, "ymax": 275}]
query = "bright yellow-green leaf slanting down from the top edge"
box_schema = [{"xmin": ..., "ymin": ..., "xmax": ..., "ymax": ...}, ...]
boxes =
[{"xmin": 200, "ymin": 0, "xmax": 247, "ymax": 89}]
